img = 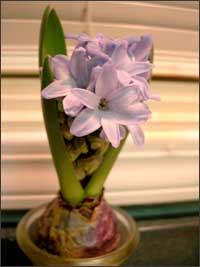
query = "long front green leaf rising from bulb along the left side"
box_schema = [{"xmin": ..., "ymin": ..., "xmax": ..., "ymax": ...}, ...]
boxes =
[{"xmin": 42, "ymin": 57, "xmax": 84, "ymax": 204}]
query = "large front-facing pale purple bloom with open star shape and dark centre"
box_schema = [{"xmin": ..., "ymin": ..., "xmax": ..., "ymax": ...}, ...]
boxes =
[{"xmin": 70, "ymin": 63, "xmax": 150, "ymax": 150}]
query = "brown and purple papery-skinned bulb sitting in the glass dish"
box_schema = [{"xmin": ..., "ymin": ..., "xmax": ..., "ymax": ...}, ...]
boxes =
[{"xmin": 34, "ymin": 194, "xmax": 120, "ymax": 258}]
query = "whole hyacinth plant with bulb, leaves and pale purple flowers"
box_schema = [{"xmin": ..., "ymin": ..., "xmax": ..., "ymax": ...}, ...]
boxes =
[{"xmin": 37, "ymin": 7, "xmax": 159, "ymax": 257}]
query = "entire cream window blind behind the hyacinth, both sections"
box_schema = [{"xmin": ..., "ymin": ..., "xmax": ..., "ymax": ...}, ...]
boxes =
[{"xmin": 1, "ymin": 1, "xmax": 198, "ymax": 209}]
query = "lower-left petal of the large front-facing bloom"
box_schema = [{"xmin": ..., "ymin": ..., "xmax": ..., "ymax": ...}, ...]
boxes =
[{"xmin": 70, "ymin": 108, "xmax": 101, "ymax": 137}]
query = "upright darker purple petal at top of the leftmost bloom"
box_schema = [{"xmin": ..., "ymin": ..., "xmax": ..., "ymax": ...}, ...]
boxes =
[{"xmin": 70, "ymin": 47, "xmax": 89, "ymax": 88}]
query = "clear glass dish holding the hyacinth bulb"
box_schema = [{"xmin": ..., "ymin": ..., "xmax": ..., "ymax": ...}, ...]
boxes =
[{"xmin": 16, "ymin": 205, "xmax": 139, "ymax": 266}]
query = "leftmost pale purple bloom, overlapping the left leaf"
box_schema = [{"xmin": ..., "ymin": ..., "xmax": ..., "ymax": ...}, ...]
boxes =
[{"xmin": 42, "ymin": 47, "xmax": 99, "ymax": 116}]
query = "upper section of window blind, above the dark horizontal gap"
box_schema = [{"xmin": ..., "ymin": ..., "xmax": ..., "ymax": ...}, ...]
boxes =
[{"xmin": 1, "ymin": 1, "xmax": 199, "ymax": 78}]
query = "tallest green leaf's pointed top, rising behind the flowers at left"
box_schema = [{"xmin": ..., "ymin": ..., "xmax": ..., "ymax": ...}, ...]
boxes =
[{"xmin": 39, "ymin": 6, "xmax": 67, "ymax": 67}]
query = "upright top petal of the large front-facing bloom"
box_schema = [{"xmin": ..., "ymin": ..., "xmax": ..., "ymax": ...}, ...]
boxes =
[{"xmin": 96, "ymin": 63, "xmax": 118, "ymax": 97}]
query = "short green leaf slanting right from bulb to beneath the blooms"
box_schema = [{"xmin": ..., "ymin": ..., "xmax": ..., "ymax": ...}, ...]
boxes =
[{"xmin": 85, "ymin": 131, "xmax": 128, "ymax": 197}]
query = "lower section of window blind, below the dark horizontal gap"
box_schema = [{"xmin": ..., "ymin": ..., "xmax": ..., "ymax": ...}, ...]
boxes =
[{"xmin": 2, "ymin": 78, "xmax": 198, "ymax": 208}]
